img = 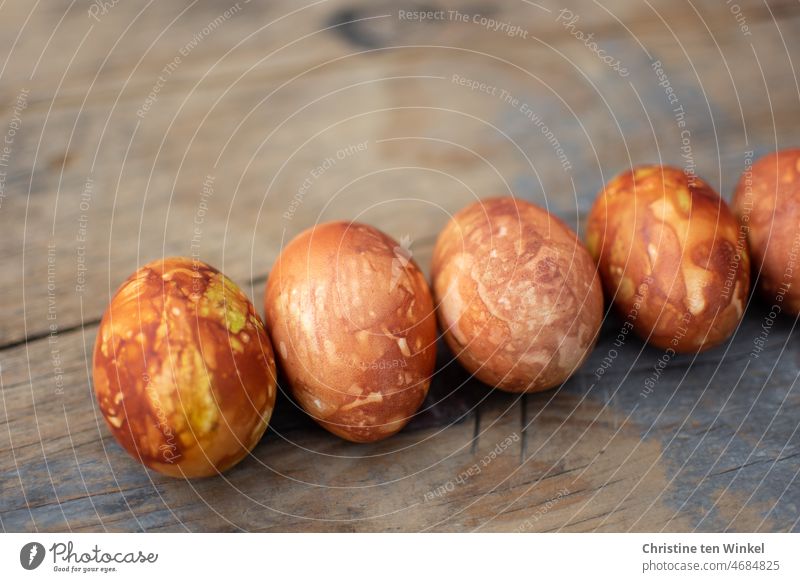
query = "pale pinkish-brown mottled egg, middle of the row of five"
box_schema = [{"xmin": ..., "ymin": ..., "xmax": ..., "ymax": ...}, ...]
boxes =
[{"xmin": 431, "ymin": 197, "xmax": 603, "ymax": 392}]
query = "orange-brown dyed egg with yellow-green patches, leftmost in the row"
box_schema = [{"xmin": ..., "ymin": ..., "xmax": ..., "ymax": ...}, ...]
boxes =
[{"xmin": 93, "ymin": 257, "xmax": 276, "ymax": 477}]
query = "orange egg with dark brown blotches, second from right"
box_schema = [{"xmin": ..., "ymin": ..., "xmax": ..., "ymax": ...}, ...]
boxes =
[{"xmin": 586, "ymin": 166, "xmax": 750, "ymax": 352}]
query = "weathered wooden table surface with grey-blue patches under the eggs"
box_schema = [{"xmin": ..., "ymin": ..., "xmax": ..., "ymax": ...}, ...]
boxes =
[{"xmin": 0, "ymin": 0, "xmax": 800, "ymax": 531}]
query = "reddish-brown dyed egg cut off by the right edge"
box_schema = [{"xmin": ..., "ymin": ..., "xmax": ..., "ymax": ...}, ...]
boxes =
[{"xmin": 732, "ymin": 149, "xmax": 800, "ymax": 315}]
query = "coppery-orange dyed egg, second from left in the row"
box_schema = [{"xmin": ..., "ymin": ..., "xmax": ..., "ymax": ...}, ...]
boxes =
[{"xmin": 264, "ymin": 222, "xmax": 436, "ymax": 442}]
